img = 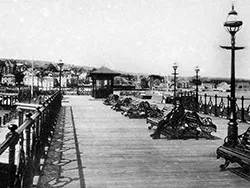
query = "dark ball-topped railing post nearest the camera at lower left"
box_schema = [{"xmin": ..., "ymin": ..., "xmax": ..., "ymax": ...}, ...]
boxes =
[{"xmin": 6, "ymin": 124, "xmax": 19, "ymax": 188}]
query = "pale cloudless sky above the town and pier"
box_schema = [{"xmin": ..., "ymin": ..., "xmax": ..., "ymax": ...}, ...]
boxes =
[{"xmin": 0, "ymin": 0, "xmax": 250, "ymax": 79}]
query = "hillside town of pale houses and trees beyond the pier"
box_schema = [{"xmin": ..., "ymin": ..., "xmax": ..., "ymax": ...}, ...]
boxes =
[{"xmin": 0, "ymin": 59, "xmax": 250, "ymax": 92}]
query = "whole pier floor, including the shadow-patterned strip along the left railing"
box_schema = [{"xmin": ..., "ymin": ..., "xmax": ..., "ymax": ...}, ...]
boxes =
[{"xmin": 36, "ymin": 96, "xmax": 250, "ymax": 188}]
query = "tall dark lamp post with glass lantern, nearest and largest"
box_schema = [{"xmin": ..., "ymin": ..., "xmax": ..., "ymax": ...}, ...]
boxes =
[{"xmin": 221, "ymin": 5, "xmax": 244, "ymax": 146}]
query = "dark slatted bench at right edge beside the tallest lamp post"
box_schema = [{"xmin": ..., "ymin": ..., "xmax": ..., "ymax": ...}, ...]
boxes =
[{"xmin": 216, "ymin": 127, "xmax": 250, "ymax": 171}]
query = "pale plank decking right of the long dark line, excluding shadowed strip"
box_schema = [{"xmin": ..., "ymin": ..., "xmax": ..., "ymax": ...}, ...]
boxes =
[{"xmin": 58, "ymin": 96, "xmax": 250, "ymax": 188}]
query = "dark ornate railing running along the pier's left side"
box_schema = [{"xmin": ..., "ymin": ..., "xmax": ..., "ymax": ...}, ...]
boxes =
[{"xmin": 0, "ymin": 92, "xmax": 62, "ymax": 188}]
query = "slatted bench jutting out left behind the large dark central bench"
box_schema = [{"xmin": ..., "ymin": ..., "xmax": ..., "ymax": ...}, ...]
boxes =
[{"xmin": 146, "ymin": 106, "xmax": 172, "ymax": 130}]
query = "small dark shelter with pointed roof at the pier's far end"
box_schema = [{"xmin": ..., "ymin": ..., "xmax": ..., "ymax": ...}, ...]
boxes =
[{"xmin": 89, "ymin": 66, "xmax": 120, "ymax": 98}]
